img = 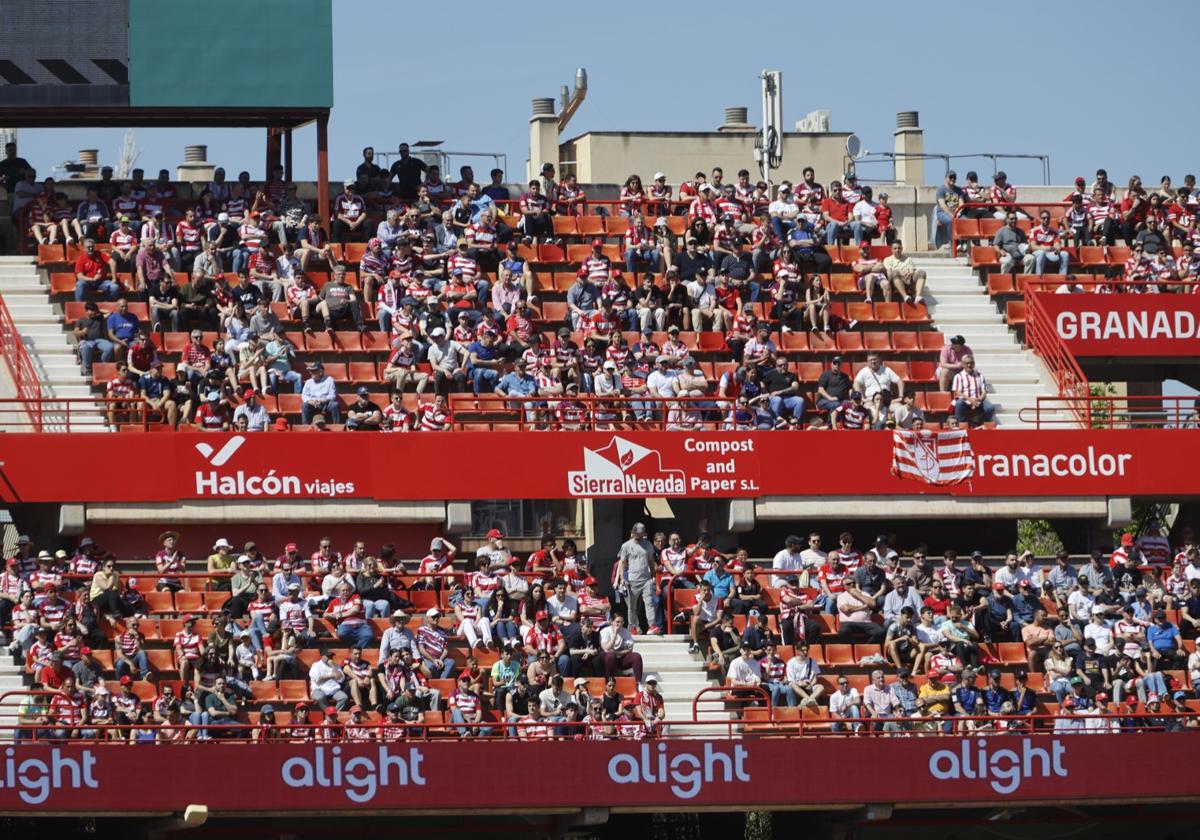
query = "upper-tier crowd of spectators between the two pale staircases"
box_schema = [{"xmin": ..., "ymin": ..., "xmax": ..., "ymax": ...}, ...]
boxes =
[{"xmin": 0, "ymin": 144, "xmax": 990, "ymax": 431}]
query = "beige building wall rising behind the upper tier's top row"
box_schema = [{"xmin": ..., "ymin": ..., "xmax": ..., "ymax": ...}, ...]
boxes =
[{"xmin": 559, "ymin": 131, "xmax": 850, "ymax": 191}]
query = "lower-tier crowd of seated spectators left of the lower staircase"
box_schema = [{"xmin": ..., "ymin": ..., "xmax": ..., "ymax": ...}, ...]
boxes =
[{"xmin": 0, "ymin": 529, "xmax": 686, "ymax": 742}]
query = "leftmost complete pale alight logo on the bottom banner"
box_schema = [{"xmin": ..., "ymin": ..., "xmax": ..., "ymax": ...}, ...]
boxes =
[{"xmin": 280, "ymin": 746, "xmax": 425, "ymax": 805}]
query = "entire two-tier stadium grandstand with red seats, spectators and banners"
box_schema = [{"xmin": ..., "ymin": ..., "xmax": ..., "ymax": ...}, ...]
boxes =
[{"xmin": 0, "ymin": 0, "xmax": 1200, "ymax": 840}]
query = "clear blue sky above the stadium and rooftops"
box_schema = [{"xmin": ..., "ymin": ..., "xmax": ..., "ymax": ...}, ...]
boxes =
[{"xmin": 9, "ymin": 0, "xmax": 1200, "ymax": 184}]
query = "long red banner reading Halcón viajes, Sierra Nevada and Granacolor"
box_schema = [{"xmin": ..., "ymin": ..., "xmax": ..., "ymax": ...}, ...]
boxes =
[{"xmin": 0, "ymin": 430, "xmax": 1200, "ymax": 503}]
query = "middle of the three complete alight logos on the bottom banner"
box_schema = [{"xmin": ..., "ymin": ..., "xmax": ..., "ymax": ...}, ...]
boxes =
[{"xmin": 608, "ymin": 742, "xmax": 750, "ymax": 799}]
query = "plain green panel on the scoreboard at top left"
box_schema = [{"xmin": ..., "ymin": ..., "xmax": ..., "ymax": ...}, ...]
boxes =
[{"xmin": 128, "ymin": 0, "xmax": 334, "ymax": 108}]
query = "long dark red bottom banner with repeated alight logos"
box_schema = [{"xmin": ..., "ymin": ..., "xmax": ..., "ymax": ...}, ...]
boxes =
[{"xmin": 0, "ymin": 733, "xmax": 1200, "ymax": 814}]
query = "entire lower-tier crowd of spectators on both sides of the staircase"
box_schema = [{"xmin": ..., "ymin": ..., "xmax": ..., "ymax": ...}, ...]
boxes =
[{"xmin": 0, "ymin": 521, "xmax": 1200, "ymax": 739}]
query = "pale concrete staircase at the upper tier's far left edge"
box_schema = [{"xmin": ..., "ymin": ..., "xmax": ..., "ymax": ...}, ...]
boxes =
[{"xmin": 0, "ymin": 257, "xmax": 107, "ymax": 432}]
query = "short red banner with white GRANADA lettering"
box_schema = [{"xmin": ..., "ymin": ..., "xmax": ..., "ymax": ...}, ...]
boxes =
[{"xmin": 1038, "ymin": 294, "xmax": 1200, "ymax": 356}]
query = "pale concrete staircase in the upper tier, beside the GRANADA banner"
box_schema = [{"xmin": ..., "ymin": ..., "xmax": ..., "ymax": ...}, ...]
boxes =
[{"xmin": 912, "ymin": 254, "xmax": 1058, "ymax": 428}]
